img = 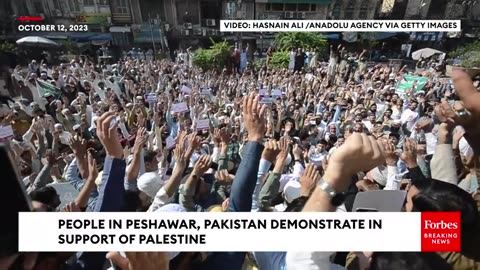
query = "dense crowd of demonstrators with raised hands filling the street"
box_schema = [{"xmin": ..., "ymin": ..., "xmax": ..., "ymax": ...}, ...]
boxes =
[{"xmin": 0, "ymin": 41, "xmax": 480, "ymax": 270}]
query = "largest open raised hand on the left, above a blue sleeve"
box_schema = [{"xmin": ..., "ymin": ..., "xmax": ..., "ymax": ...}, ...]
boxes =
[{"xmin": 97, "ymin": 112, "xmax": 123, "ymax": 159}]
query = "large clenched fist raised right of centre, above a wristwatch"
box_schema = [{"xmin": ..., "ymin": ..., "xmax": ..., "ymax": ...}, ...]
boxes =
[{"xmin": 324, "ymin": 133, "xmax": 385, "ymax": 192}]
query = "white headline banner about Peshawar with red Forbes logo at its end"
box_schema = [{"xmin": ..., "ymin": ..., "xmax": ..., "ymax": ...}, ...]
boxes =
[{"xmin": 19, "ymin": 212, "xmax": 461, "ymax": 252}]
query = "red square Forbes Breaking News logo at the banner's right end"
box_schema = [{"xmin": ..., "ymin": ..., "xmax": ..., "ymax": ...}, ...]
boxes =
[{"xmin": 422, "ymin": 212, "xmax": 461, "ymax": 252}]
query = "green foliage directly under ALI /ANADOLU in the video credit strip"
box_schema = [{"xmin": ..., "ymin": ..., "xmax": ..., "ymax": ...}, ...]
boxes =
[{"xmin": 275, "ymin": 32, "xmax": 328, "ymax": 52}]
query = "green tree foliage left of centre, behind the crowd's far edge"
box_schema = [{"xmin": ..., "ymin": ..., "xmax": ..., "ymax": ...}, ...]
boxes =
[{"xmin": 193, "ymin": 39, "xmax": 233, "ymax": 70}]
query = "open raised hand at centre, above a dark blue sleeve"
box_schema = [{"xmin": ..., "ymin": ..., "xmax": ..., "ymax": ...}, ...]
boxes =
[{"xmin": 243, "ymin": 94, "xmax": 266, "ymax": 143}]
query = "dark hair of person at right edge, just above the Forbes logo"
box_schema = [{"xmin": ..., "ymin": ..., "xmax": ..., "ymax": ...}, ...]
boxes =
[{"xmin": 412, "ymin": 179, "xmax": 479, "ymax": 234}]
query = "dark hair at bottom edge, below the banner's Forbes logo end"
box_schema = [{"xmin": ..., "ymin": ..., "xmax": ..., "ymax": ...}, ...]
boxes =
[{"xmin": 369, "ymin": 252, "xmax": 453, "ymax": 270}]
